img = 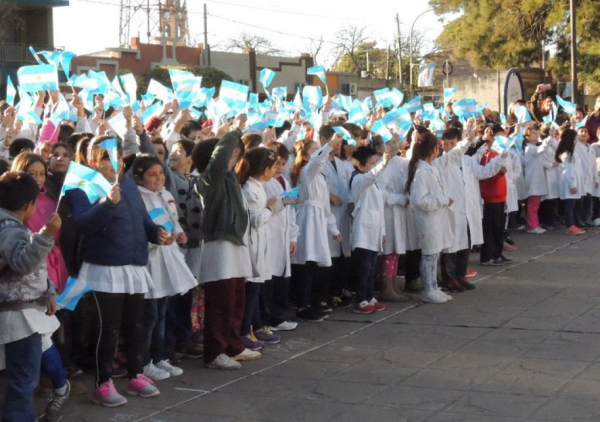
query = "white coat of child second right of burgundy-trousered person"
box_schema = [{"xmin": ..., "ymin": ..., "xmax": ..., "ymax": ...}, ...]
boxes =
[{"xmin": 263, "ymin": 178, "xmax": 298, "ymax": 277}]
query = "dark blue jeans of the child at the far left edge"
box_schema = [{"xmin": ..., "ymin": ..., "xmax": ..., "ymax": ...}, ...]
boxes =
[{"xmin": 2, "ymin": 334, "xmax": 42, "ymax": 422}]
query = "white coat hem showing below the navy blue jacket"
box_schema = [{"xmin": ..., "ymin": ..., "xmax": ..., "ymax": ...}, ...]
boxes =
[{"xmin": 78, "ymin": 262, "xmax": 154, "ymax": 294}]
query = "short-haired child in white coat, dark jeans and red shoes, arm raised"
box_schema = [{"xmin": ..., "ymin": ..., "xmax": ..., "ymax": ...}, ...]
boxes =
[{"xmin": 350, "ymin": 147, "xmax": 390, "ymax": 314}]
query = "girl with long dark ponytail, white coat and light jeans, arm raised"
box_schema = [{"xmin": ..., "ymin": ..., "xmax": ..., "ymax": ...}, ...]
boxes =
[{"xmin": 406, "ymin": 120, "xmax": 474, "ymax": 303}]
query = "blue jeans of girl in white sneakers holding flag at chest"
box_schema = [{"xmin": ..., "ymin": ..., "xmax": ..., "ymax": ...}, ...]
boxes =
[{"xmin": 144, "ymin": 297, "xmax": 169, "ymax": 366}]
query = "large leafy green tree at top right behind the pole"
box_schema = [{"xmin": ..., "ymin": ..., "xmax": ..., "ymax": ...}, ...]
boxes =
[{"xmin": 429, "ymin": 0, "xmax": 600, "ymax": 92}]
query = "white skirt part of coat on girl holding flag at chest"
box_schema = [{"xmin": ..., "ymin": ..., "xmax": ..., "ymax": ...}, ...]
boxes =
[{"xmin": 145, "ymin": 243, "xmax": 198, "ymax": 299}]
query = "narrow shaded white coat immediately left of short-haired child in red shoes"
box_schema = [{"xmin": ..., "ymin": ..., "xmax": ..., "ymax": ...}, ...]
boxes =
[{"xmin": 323, "ymin": 157, "xmax": 352, "ymax": 258}]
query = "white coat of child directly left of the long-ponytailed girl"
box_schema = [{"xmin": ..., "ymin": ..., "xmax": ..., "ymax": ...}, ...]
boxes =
[{"xmin": 377, "ymin": 156, "xmax": 408, "ymax": 255}]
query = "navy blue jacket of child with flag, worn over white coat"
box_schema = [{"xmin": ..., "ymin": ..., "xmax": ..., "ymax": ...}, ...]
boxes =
[{"xmin": 70, "ymin": 176, "xmax": 160, "ymax": 266}]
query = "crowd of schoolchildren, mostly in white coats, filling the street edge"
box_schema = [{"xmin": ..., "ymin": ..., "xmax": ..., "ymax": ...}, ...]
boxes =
[{"xmin": 0, "ymin": 79, "xmax": 600, "ymax": 422}]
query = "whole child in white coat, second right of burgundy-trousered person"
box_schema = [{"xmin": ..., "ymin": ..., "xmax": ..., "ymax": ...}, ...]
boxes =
[{"xmin": 262, "ymin": 142, "xmax": 298, "ymax": 331}]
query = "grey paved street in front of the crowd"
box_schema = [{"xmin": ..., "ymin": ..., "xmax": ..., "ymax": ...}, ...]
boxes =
[{"xmin": 5, "ymin": 230, "xmax": 600, "ymax": 422}]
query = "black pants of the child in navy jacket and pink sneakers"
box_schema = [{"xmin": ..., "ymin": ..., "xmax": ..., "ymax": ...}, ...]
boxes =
[{"xmin": 93, "ymin": 292, "xmax": 145, "ymax": 386}]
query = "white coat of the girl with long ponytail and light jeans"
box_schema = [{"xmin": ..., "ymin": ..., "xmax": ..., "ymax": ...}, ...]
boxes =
[{"xmin": 410, "ymin": 140, "xmax": 470, "ymax": 255}]
